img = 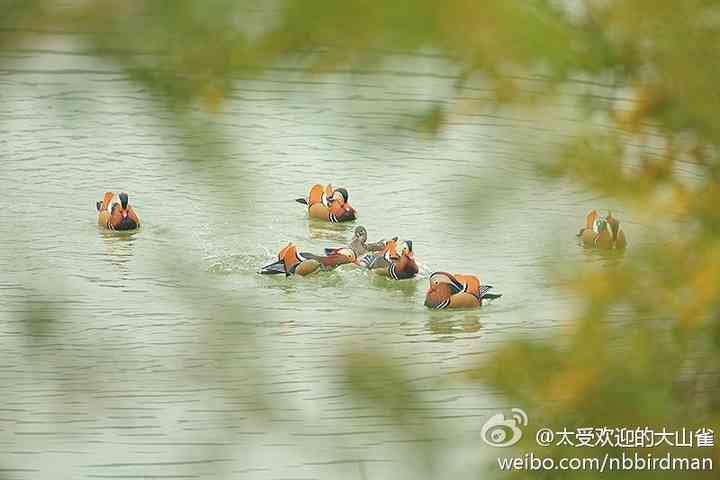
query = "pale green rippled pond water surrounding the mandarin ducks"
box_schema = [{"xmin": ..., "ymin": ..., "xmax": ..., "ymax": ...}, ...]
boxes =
[{"xmin": 0, "ymin": 31, "xmax": 646, "ymax": 479}]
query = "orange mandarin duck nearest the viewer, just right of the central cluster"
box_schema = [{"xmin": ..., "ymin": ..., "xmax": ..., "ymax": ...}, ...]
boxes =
[{"xmin": 425, "ymin": 272, "xmax": 502, "ymax": 310}]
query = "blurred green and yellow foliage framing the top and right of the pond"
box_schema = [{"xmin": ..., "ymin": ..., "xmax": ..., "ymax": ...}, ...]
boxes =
[{"xmin": 0, "ymin": 0, "xmax": 720, "ymax": 478}]
